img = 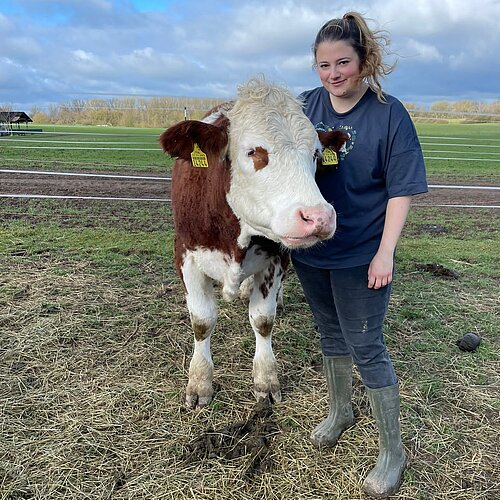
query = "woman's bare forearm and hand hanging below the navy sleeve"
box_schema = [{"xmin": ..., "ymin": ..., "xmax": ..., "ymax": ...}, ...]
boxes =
[{"xmin": 368, "ymin": 196, "xmax": 411, "ymax": 289}]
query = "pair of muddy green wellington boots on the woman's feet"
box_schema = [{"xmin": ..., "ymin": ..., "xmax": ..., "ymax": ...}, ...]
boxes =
[{"xmin": 311, "ymin": 356, "xmax": 406, "ymax": 498}]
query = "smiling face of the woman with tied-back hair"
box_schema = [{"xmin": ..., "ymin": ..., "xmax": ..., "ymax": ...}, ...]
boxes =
[{"xmin": 316, "ymin": 40, "xmax": 362, "ymax": 98}]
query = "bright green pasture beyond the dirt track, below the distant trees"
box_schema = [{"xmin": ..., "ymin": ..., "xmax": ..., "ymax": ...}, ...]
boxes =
[{"xmin": 0, "ymin": 123, "xmax": 500, "ymax": 184}]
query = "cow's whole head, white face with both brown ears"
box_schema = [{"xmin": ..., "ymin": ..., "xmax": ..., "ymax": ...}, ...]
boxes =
[{"xmin": 160, "ymin": 79, "xmax": 347, "ymax": 248}]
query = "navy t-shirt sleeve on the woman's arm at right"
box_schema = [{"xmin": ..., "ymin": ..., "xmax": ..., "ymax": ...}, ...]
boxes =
[{"xmin": 385, "ymin": 105, "xmax": 428, "ymax": 198}]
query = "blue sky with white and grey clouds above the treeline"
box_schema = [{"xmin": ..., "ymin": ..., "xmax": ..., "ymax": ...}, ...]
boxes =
[{"xmin": 0, "ymin": 0, "xmax": 500, "ymax": 110}]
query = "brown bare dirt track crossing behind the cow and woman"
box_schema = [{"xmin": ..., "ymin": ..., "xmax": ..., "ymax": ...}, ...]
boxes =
[{"xmin": 0, "ymin": 172, "xmax": 500, "ymax": 206}]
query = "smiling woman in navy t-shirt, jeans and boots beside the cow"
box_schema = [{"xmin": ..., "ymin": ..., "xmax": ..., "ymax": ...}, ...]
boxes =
[{"xmin": 292, "ymin": 12, "xmax": 427, "ymax": 498}]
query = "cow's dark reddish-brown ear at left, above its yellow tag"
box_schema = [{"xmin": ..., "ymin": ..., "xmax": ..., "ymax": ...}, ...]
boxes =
[{"xmin": 160, "ymin": 120, "xmax": 228, "ymax": 160}]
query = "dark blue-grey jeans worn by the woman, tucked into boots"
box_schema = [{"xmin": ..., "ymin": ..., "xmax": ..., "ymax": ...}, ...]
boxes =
[{"xmin": 292, "ymin": 258, "xmax": 397, "ymax": 389}]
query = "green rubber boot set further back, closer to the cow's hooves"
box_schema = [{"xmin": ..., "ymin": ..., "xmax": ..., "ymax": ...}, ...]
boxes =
[{"xmin": 311, "ymin": 356, "xmax": 354, "ymax": 448}]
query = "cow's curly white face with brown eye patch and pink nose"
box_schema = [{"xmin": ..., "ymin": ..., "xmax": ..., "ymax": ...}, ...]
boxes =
[{"xmin": 227, "ymin": 82, "xmax": 336, "ymax": 248}]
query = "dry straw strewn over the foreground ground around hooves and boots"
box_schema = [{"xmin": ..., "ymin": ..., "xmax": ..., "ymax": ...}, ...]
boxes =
[{"xmin": 0, "ymin": 205, "xmax": 500, "ymax": 500}]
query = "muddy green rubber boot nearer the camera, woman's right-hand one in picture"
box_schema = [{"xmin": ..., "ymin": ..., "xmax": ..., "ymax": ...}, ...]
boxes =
[{"xmin": 363, "ymin": 384, "xmax": 406, "ymax": 498}]
